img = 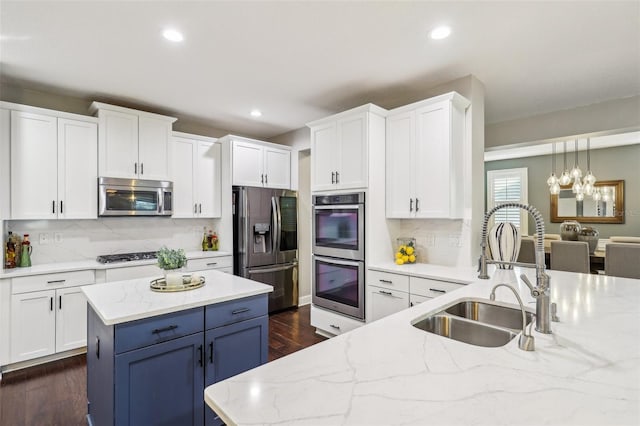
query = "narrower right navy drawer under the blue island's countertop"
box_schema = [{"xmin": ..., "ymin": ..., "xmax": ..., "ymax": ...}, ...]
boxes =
[{"xmin": 204, "ymin": 294, "xmax": 268, "ymax": 330}]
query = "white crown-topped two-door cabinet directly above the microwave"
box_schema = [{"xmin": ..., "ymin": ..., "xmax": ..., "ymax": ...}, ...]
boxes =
[{"xmin": 90, "ymin": 102, "xmax": 176, "ymax": 180}]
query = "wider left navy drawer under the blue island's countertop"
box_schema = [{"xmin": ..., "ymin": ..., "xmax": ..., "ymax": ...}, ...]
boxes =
[{"xmin": 115, "ymin": 308, "xmax": 204, "ymax": 354}]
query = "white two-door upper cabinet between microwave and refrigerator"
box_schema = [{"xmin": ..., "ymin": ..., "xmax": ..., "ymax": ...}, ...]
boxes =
[{"xmin": 169, "ymin": 132, "xmax": 222, "ymax": 218}]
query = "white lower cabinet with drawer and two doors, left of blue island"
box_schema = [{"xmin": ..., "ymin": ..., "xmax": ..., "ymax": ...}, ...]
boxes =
[{"xmin": 9, "ymin": 271, "xmax": 95, "ymax": 363}]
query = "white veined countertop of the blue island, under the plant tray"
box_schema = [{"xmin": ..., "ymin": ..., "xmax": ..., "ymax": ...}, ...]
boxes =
[{"xmin": 82, "ymin": 270, "xmax": 273, "ymax": 325}]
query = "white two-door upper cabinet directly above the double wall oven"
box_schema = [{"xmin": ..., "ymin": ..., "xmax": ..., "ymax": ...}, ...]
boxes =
[{"xmin": 307, "ymin": 104, "xmax": 386, "ymax": 191}]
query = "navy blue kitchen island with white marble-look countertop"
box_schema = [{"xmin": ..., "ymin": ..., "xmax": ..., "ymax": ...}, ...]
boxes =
[{"xmin": 82, "ymin": 270, "xmax": 273, "ymax": 425}]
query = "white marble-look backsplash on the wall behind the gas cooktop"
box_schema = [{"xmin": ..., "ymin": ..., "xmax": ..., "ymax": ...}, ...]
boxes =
[{"xmin": 3, "ymin": 217, "xmax": 222, "ymax": 265}]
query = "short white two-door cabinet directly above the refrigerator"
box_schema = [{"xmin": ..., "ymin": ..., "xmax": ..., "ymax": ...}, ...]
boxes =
[{"xmin": 221, "ymin": 135, "xmax": 291, "ymax": 189}]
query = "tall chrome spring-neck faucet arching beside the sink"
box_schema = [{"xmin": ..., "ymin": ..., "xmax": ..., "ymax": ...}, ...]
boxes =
[{"xmin": 478, "ymin": 203, "xmax": 551, "ymax": 334}]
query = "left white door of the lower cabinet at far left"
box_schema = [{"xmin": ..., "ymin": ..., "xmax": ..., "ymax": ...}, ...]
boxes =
[{"xmin": 11, "ymin": 290, "xmax": 56, "ymax": 363}]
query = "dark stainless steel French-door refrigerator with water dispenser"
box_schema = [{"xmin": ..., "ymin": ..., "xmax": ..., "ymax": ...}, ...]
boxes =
[{"xmin": 233, "ymin": 186, "xmax": 298, "ymax": 312}]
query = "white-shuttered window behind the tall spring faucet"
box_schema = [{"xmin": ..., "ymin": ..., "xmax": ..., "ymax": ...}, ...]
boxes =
[{"xmin": 487, "ymin": 167, "xmax": 528, "ymax": 235}]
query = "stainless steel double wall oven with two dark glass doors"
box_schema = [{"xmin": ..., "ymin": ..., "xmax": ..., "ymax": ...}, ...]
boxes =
[{"xmin": 312, "ymin": 192, "xmax": 365, "ymax": 320}]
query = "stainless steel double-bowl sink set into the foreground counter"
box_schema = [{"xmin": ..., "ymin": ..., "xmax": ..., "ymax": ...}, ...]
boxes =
[{"xmin": 411, "ymin": 299, "xmax": 533, "ymax": 348}]
